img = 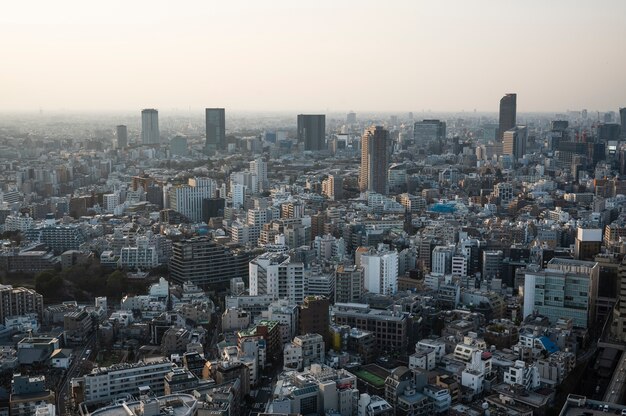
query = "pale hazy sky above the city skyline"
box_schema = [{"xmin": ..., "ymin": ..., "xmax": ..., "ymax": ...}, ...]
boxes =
[{"xmin": 0, "ymin": 0, "xmax": 626, "ymax": 113}]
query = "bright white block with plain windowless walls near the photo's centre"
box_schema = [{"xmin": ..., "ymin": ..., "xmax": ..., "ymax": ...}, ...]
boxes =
[{"xmin": 360, "ymin": 244, "xmax": 398, "ymax": 295}]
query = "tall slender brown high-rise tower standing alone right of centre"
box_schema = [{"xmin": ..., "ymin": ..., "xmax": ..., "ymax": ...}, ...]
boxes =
[{"xmin": 359, "ymin": 126, "xmax": 389, "ymax": 195}]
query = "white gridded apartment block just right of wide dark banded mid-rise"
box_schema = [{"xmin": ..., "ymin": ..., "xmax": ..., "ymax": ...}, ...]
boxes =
[{"xmin": 249, "ymin": 253, "xmax": 304, "ymax": 303}]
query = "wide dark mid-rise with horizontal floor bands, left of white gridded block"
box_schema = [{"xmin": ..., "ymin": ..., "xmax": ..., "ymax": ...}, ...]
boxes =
[{"xmin": 169, "ymin": 237, "xmax": 251, "ymax": 289}]
